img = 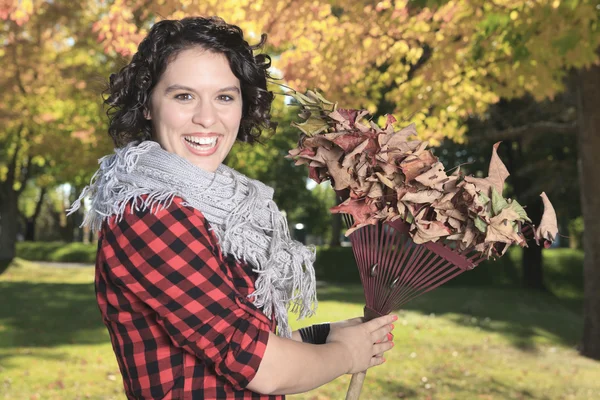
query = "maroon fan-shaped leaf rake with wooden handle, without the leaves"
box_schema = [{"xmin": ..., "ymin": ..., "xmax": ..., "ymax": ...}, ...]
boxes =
[{"xmin": 343, "ymin": 214, "xmax": 486, "ymax": 400}]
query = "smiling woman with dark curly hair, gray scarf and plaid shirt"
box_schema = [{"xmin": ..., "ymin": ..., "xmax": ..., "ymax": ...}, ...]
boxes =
[{"xmin": 70, "ymin": 17, "xmax": 396, "ymax": 399}]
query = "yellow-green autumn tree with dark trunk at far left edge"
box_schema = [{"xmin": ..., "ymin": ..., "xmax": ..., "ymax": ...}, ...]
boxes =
[{"xmin": 0, "ymin": 0, "xmax": 110, "ymax": 271}]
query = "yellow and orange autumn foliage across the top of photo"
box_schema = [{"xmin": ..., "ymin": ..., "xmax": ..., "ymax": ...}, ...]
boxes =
[{"xmin": 0, "ymin": 0, "xmax": 600, "ymax": 192}]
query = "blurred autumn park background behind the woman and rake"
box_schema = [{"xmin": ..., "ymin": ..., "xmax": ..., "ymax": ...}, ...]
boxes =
[{"xmin": 0, "ymin": 0, "xmax": 600, "ymax": 399}]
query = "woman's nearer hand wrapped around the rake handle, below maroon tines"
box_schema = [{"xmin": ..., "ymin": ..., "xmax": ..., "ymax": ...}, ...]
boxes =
[{"xmin": 327, "ymin": 315, "xmax": 398, "ymax": 374}]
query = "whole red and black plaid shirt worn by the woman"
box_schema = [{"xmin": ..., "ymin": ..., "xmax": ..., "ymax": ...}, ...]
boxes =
[{"xmin": 95, "ymin": 197, "xmax": 284, "ymax": 400}]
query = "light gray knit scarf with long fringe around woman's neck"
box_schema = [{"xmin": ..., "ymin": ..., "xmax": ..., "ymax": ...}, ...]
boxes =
[{"xmin": 68, "ymin": 141, "xmax": 317, "ymax": 338}]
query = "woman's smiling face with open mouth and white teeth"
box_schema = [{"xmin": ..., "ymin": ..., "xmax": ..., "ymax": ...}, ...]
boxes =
[{"xmin": 146, "ymin": 47, "xmax": 242, "ymax": 172}]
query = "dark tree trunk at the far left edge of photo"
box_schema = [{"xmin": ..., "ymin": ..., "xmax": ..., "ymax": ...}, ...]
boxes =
[{"xmin": 0, "ymin": 183, "xmax": 19, "ymax": 274}]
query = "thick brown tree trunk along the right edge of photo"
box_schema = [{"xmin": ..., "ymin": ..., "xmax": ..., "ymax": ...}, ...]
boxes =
[{"xmin": 577, "ymin": 50, "xmax": 600, "ymax": 360}]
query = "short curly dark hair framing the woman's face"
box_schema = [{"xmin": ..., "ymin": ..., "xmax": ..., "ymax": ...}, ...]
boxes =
[{"xmin": 104, "ymin": 17, "xmax": 276, "ymax": 147}]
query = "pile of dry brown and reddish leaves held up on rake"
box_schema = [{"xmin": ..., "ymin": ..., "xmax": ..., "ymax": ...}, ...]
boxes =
[{"xmin": 287, "ymin": 90, "xmax": 558, "ymax": 258}]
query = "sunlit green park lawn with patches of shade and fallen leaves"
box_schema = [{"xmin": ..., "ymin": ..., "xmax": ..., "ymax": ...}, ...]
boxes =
[{"xmin": 0, "ymin": 259, "xmax": 600, "ymax": 400}]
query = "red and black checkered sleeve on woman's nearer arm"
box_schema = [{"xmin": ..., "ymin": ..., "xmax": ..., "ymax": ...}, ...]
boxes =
[{"xmin": 105, "ymin": 198, "xmax": 271, "ymax": 390}]
